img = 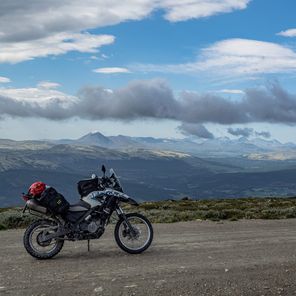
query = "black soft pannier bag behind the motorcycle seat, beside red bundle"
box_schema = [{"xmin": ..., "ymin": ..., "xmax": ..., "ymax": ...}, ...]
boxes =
[{"xmin": 37, "ymin": 187, "xmax": 70, "ymax": 215}]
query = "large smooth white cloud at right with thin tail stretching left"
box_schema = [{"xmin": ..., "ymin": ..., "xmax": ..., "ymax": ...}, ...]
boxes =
[{"xmin": 134, "ymin": 39, "xmax": 296, "ymax": 78}]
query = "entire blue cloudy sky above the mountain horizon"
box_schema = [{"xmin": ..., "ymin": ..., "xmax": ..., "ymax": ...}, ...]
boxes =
[{"xmin": 0, "ymin": 0, "xmax": 296, "ymax": 142}]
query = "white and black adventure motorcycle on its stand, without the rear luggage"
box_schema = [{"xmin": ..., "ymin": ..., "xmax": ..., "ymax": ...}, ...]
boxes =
[{"xmin": 23, "ymin": 165, "xmax": 153, "ymax": 259}]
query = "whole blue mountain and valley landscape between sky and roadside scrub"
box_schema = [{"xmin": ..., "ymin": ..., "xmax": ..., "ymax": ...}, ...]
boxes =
[{"xmin": 0, "ymin": 132, "xmax": 296, "ymax": 207}]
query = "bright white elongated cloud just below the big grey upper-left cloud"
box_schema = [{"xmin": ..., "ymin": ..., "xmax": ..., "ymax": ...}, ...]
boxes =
[{"xmin": 0, "ymin": 33, "xmax": 115, "ymax": 63}]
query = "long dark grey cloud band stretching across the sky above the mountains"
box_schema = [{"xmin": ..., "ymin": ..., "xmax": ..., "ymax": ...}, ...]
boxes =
[{"xmin": 0, "ymin": 80, "xmax": 296, "ymax": 125}]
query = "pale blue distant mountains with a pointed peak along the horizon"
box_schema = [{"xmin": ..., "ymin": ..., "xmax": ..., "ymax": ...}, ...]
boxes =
[{"xmin": 54, "ymin": 131, "xmax": 296, "ymax": 157}]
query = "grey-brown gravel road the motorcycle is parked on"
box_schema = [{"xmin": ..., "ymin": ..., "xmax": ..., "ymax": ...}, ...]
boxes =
[{"xmin": 0, "ymin": 219, "xmax": 296, "ymax": 296}]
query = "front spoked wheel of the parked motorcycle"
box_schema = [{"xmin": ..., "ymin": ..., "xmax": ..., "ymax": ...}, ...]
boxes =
[{"xmin": 114, "ymin": 213, "xmax": 153, "ymax": 254}]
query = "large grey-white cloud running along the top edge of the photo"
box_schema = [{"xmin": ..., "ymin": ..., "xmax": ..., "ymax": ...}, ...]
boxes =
[{"xmin": 0, "ymin": 0, "xmax": 250, "ymax": 41}]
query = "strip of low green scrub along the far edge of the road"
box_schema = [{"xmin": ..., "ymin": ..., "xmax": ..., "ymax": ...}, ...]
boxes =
[{"xmin": 0, "ymin": 198, "xmax": 296, "ymax": 230}]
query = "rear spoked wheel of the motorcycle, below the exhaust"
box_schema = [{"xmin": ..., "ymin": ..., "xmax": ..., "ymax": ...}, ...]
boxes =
[{"xmin": 24, "ymin": 220, "xmax": 64, "ymax": 259}]
